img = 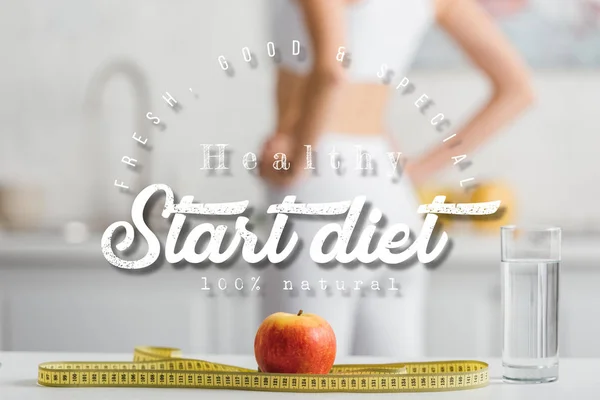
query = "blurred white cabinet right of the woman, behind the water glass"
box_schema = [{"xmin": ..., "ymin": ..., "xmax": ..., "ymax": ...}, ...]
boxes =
[{"xmin": 428, "ymin": 265, "xmax": 600, "ymax": 357}]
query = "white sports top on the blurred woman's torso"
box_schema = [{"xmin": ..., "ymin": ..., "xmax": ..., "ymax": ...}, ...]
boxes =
[{"xmin": 270, "ymin": 0, "xmax": 435, "ymax": 82}]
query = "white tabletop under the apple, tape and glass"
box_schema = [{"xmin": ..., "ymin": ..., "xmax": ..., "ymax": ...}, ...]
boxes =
[{"xmin": 0, "ymin": 352, "xmax": 600, "ymax": 400}]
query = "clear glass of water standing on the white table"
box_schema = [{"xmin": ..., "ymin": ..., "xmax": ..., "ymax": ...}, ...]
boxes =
[{"xmin": 501, "ymin": 226, "xmax": 561, "ymax": 383}]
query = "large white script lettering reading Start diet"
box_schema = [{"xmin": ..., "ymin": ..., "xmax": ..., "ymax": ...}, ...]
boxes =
[{"xmin": 101, "ymin": 184, "xmax": 500, "ymax": 269}]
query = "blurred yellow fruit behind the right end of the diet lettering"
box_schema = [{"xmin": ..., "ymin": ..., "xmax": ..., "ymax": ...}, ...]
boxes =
[{"xmin": 470, "ymin": 182, "xmax": 516, "ymax": 233}]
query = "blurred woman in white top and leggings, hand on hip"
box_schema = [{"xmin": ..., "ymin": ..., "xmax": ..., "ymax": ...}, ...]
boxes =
[{"xmin": 260, "ymin": 0, "xmax": 532, "ymax": 358}]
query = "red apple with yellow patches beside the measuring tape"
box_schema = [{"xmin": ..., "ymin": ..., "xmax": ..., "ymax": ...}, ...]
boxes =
[{"xmin": 254, "ymin": 310, "xmax": 336, "ymax": 374}]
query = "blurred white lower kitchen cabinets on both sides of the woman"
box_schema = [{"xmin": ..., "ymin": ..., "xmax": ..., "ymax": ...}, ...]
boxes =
[{"xmin": 0, "ymin": 247, "xmax": 600, "ymax": 357}]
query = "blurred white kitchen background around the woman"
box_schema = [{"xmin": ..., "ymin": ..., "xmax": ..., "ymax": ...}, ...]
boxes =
[{"xmin": 0, "ymin": 0, "xmax": 600, "ymax": 357}]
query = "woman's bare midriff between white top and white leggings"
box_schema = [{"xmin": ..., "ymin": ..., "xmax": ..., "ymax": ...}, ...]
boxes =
[{"xmin": 277, "ymin": 68, "xmax": 390, "ymax": 135}]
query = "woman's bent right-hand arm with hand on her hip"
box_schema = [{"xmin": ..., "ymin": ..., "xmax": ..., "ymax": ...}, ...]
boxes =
[{"xmin": 406, "ymin": 0, "xmax": 533, "ymax": 184}]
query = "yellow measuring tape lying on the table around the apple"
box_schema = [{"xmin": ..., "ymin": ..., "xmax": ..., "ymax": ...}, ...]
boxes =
[{"xmin": 38, "ymin": 347, "xmax": 489, "ymax": 393}]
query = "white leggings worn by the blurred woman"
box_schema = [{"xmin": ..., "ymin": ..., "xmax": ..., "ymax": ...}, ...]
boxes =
[{"xmin": 261, "ymin": 133, "xmax": 429, "ymax": 359}]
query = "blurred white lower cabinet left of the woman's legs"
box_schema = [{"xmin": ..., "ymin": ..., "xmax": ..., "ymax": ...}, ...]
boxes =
[{"xmin": 0, "ymin": 264, "xmax": 257, "ymax": 353}]
